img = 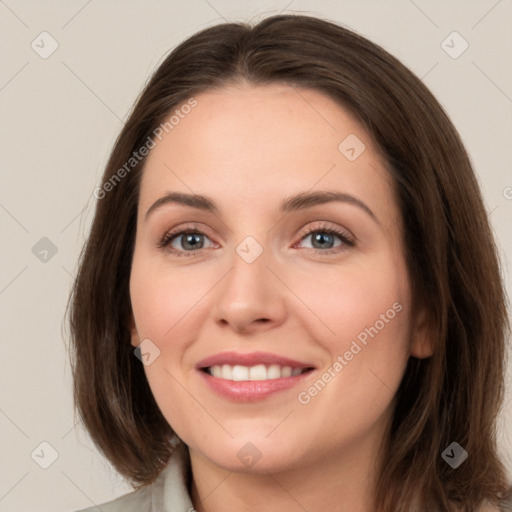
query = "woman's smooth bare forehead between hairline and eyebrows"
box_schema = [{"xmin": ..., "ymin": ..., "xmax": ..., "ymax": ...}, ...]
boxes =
[{"xmin": 140, "ymin": 84, "xmax": 394, "ymax": 220}]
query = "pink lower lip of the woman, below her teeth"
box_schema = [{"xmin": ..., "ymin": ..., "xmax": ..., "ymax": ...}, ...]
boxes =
[{"xmin": 199, "ymin": 370, "xmax": 312, "ymax": 402}]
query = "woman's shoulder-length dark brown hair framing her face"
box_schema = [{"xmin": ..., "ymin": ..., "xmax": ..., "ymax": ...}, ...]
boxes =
[{"xmin": 68, "ymin": 15, "xmax": 510, "ymax": 512}]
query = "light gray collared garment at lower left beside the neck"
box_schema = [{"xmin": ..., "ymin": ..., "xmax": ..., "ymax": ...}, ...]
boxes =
[{"xmin": 77, "ymin": 444, "xmax": 194, "ymax": 512}]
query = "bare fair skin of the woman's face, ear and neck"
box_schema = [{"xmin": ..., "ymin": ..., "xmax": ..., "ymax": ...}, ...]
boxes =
[{"xmin": 130, "ymin": 83, "xmax": 432, "ymax": 512}]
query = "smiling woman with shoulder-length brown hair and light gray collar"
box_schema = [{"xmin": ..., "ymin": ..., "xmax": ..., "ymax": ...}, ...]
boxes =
[{"xmin": 70, "ymin": 15, "xmax": 511, "ymax": 512}]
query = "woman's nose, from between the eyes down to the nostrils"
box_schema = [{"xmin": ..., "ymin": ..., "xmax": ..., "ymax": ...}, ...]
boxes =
[{"xmin": 213, "ymin": 240, "xmax": 287, "ymax": 334}]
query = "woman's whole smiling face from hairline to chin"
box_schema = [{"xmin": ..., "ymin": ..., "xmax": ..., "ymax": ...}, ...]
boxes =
[{"xmin": 130, "ymin": 84, "xmax": 429, "ymax": 472}]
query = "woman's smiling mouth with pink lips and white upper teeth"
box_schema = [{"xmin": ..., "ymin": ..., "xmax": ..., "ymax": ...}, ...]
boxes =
[{"xmin": 196, "ymin": 352, "xmax": 315, "ymax": 402}]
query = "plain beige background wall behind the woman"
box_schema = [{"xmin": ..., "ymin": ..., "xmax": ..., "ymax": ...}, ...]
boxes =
[{"xmin": 0, "ymin": 0, "xmax": 512, "ymax": 512}]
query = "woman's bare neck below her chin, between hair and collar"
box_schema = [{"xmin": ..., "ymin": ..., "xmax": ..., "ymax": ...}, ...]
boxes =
[{"xmin": 190, "ymin": 439, "xmax": 384, "ymax": 512}]
